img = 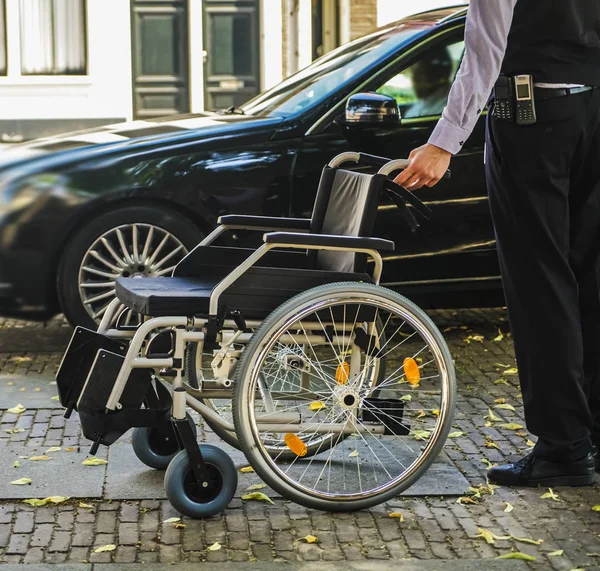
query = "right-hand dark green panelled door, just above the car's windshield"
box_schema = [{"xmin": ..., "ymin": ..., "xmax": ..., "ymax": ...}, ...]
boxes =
[{"xmin": 204, "ymin": 0, "xmax": 260, "ymax": 109}]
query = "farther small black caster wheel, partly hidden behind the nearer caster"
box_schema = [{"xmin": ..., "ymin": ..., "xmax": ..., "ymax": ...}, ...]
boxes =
[{"xmin": 131, "ymin": 413, "xmax": 197, "ymax": 470}]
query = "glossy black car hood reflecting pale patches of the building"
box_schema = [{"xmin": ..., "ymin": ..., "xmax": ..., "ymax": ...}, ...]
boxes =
[{"xmin": 0, "ymin": 113, "xmax": 283, "ymax": 169}]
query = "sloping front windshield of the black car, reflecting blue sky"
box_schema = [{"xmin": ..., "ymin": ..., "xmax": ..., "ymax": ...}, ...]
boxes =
[{"xmin": 242, "ymin": 24, "xmax": 428, "ymax": 117}]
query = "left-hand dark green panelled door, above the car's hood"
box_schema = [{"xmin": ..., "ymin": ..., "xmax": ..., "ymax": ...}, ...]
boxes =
[{"xmin": 131, "ymin": 0, "xmax": 190, "ymax": 119}]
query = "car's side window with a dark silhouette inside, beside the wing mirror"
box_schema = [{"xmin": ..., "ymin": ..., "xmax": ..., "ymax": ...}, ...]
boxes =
[{"xmin": 376, "ymin": 40, "xmax": 465, "ymax": 119}]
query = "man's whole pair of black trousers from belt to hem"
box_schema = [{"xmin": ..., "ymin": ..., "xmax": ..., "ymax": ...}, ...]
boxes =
[{"xmin": 486, "ymin": 89, "xmax": 600, "ymax": 461}]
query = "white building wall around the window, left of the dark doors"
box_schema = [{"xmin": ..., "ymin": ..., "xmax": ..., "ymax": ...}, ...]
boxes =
[{"xmin": 0, "ymin": 0, "xmax": 132, "ymax": 138}]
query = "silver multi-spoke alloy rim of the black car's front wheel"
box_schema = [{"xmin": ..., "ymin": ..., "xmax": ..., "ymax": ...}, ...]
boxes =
[{"xmin": 78, "ymin": 223, "xmax": 188, "ymax": 326}]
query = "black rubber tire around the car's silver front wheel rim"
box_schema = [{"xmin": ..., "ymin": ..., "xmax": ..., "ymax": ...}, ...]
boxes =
[{"xmin": 57, "ymin": 204, "xmax": 203, "ymax": 329}]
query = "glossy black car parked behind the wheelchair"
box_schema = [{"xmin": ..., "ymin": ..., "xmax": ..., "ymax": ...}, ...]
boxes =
[{"xmin": 0, "ymin": 7, "xmax": 503, "ymax": 326}]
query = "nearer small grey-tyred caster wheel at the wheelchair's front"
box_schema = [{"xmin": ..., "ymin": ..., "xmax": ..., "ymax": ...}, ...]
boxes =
[{"xmin": 165, "ymin": 444, "xmax": 238, "ymax": 518}]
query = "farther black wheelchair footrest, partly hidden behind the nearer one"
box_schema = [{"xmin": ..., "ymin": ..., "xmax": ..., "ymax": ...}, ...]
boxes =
[{"xmin": 56, "ymin": 327, "xmax": 127, "ymax": 416}]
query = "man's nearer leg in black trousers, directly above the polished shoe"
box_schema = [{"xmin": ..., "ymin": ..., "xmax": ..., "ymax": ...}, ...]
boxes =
[{"xmin": 486, "ymin": 98, "xmax": 592, "ymax": 470}]
